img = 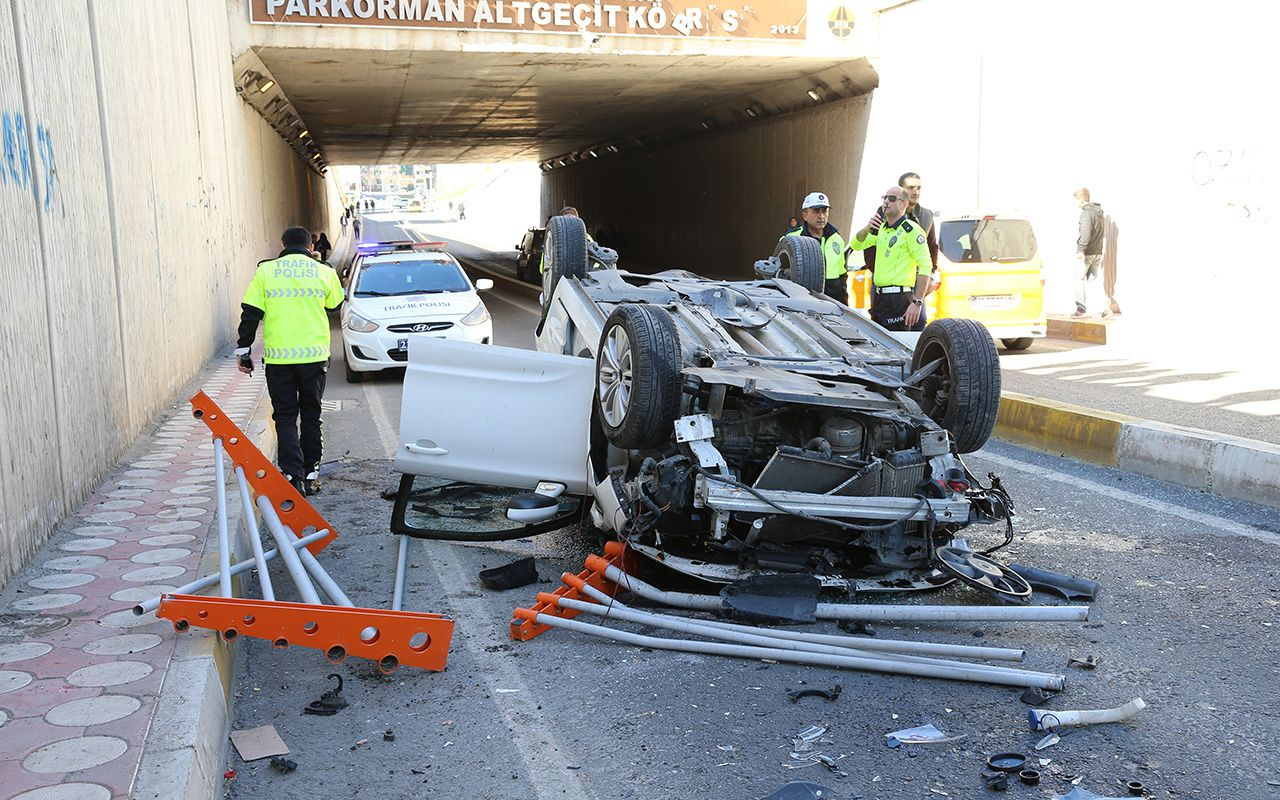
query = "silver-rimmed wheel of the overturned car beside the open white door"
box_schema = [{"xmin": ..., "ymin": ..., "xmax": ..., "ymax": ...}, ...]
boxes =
[{"xmin": 595, "ymin": 303, "xmax": 682, "ymax": 449}]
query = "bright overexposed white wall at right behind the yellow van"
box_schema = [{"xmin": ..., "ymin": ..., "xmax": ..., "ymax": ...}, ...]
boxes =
[{"xmin": 846, "ymin": 0, "xmax": 1280, "ymax": 352}]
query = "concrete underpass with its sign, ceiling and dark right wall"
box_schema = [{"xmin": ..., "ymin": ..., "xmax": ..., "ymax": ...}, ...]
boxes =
[{"xmin": 236, "ymin": 0, "xmax": 878, "ymax": 276}]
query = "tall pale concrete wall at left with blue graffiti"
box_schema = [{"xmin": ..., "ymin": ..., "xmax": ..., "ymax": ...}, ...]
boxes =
[{"xmin": 0, "ymin": 0, "xmax": 338, "ymax": 582}]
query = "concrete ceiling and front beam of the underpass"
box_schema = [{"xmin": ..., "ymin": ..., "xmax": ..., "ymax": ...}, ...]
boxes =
[{"xmin": 233, "ymin": 0, "xmax": 878, "ymax": 164}]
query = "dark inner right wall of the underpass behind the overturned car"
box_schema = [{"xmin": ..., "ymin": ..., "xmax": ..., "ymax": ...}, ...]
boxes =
[{"xmin": 541, "ymin": 96, "xmax": 870, "ymax": 278}]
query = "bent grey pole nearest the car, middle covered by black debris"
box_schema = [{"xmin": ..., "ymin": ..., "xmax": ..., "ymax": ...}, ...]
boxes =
[{"xmin": 586, "ymin": 556, "xmax": 1089, "ymax": 622}]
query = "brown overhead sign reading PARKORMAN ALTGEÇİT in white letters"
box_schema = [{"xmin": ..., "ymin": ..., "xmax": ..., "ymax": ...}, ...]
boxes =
[{"xmin": 250, "ymin": 0, "xmax": 808, "ymax": 41}]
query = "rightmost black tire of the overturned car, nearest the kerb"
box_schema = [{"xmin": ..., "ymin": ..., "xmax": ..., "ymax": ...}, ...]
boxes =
[{"xmin": 911, "ymin": 317, "xmax": 1000, "ymax": 453}]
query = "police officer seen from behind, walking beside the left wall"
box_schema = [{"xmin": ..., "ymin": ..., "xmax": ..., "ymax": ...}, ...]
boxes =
[{"xmin": 236, "ymin": 228, "xmax": 342, "ymax": 494}]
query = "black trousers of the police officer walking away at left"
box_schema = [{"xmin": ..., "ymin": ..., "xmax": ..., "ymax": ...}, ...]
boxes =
[{"xmin": 264, "ymin": 361, "xmax": 329, "ymax": 480}]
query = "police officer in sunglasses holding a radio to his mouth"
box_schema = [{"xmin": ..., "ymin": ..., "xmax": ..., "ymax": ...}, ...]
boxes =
[{"xmin": 849, "ymin": 186, "xmax": 933, "ymax": 330}]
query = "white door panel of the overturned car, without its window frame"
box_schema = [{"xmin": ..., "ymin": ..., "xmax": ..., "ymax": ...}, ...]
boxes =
[{"xmin": 396, "ymin": 337, "xmax": 595, "ymax": 495}]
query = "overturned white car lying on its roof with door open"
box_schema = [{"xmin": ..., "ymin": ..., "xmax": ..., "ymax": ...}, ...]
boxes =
[{"xmin": 393, "ymin": 218, "xmax": 1030, "ymax": 602}]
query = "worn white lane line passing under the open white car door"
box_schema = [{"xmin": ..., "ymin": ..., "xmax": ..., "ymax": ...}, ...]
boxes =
[{"xmin": 361, "ymin": 383, "xmax": 590, "ymax": 800}]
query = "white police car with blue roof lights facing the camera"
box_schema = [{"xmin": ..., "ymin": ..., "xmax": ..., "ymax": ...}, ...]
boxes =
[{"xmin": 340, "ymin": 242, "xmax": 493, "ymax": 383}]
